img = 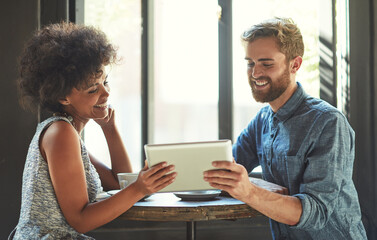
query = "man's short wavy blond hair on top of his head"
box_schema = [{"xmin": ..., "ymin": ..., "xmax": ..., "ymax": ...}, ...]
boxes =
[{"xmin": 241, "ymin": 18, "xmax": 304, "ymax": 61}]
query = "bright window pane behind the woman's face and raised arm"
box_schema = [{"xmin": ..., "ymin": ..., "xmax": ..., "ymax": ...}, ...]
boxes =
[{"xmin": 85, "ymin": 0, "xmax": 142, "ymax": 171}]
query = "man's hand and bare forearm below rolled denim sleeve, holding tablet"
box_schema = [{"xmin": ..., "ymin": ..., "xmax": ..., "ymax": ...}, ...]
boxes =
[{"xmin": 203, "ymin": 161, "xmax": 302, "ymax": 225}]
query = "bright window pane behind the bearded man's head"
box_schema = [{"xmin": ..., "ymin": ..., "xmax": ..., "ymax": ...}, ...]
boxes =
[{"xmin": 233, "ymin": 0, "xmax": 318, "ymax": 172}]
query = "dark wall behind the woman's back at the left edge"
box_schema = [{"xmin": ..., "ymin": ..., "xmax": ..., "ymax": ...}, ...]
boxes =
[{"xmin": 0, "ymin": 0, "xmax": 38, "ymax": 239}]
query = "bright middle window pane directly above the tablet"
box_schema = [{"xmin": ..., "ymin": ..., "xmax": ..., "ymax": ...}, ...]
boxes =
[{"xmin": 149, "ymin": 0, "xmax": 218, "ymax": 143}]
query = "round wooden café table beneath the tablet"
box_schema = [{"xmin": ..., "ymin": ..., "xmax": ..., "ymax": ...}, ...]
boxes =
[{"xmin": 119, "ymin": 193, "xmax": 262, "ymax": 240}]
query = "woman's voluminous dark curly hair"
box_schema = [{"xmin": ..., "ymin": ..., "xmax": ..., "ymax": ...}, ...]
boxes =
[{"xmin": 18, "ymin": 22, "xmax": 117, "ymax": 112}]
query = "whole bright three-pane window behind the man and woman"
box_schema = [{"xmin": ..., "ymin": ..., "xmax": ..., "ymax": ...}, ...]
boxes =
[{"xmin": 85, "ymin": 0, "xmax": 320, "ymax": 171}]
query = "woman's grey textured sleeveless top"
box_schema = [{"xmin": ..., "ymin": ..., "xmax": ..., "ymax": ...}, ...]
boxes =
[{"xmin": 13, "ymin": 116, "xmax": 102, "ymax": 240}]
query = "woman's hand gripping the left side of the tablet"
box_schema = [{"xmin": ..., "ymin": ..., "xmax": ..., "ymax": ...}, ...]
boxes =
[{"xmin": 133, "ymin": 162, "xmax": 177, "ymax": 195}]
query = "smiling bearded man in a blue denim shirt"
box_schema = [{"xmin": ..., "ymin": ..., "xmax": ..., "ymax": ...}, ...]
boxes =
[{"xmin": 204, "ymin": 18, "xmax": 367, "ymax": 240}]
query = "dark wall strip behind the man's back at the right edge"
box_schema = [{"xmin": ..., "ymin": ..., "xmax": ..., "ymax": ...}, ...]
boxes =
[{"xmin": 350, "ymin": 0, "xmax": 377, "ymax": 239}]
